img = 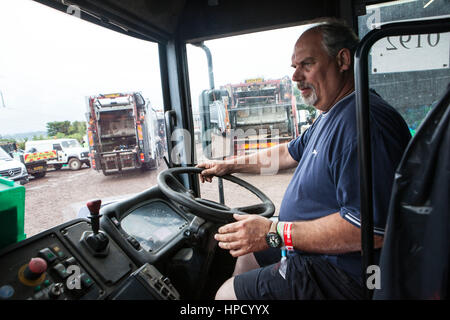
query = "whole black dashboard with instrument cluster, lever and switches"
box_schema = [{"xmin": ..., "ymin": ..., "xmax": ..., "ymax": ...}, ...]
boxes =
[{"xmin": 0, "ymin": 186, "xmax": 220, "ymax": 300}]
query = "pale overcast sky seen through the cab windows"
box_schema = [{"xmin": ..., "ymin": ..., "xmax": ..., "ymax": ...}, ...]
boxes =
[{"xmin": 0, "ymin": 0, "xmax": 303, "ymax": 135}]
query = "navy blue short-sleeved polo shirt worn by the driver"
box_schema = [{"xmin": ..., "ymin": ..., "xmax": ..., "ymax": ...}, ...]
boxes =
[{"xmin": 279, "ymin": 92, "xmax": 411, "ymax": 278}]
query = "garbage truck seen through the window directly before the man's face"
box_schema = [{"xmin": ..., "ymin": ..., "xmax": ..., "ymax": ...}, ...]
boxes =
[{"xmin": 199, "ymin": 76, "xmax": 299, "ymax": 156}]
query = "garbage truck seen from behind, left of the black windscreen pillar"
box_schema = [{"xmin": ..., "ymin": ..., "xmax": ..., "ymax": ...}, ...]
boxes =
[{"xmin": 86, "ymin": 92, "xmax": 161, "ymax": 175}]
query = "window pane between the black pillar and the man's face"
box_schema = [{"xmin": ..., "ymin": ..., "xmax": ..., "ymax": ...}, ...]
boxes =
[{"xmin": 187, "ymin": 26, "xmax": 316, "ymax": 215}]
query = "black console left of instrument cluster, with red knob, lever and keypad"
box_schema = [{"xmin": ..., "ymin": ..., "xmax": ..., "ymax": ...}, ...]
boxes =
[{"xmin": 0, "ymin": 219, "xmax": 180, "ymax": 300}]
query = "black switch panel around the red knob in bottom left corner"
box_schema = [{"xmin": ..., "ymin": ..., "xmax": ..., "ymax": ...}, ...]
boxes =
[{"xmin": 0, "ymin": 233, "xmax": 103, "ymax": 300}]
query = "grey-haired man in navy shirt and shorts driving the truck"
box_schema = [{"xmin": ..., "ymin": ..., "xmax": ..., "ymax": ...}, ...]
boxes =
[{"xmin": 197, "ymin": 18, "xmax": 411, "ymax": 300}]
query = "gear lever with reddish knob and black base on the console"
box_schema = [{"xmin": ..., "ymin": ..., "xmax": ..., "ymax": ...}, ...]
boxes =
[{"xmin": 80, "ymin": 199, "xmax": 109, "ymax": 257}]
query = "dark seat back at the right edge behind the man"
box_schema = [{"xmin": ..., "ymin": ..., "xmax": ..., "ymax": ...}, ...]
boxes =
[{"xmin": 374, "ymin": 84, "xmax": 450, "ymax": 299}]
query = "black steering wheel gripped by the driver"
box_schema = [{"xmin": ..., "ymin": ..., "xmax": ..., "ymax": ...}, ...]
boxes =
[{"xmin": 157, "ymin": 167, "xmax": 275, "ymax": 223}]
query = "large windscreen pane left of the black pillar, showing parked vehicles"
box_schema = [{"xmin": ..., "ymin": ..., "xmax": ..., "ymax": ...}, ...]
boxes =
[{"xmin": 0, "ymin": 0, "xmax": 166, "ymax": 237}]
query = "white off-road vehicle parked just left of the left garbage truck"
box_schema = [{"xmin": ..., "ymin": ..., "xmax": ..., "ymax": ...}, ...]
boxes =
[{"xmin": 25, "ymin": 139, "xmax": 91, "ymax": 170}]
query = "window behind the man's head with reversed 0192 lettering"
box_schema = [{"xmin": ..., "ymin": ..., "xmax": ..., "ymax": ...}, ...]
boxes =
[{"xmin": 358, "ymin": 0, "xmax": 450, "ymax": 135}]
